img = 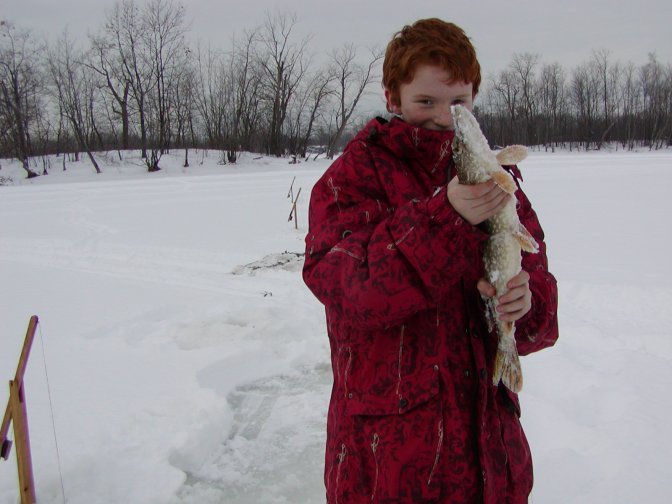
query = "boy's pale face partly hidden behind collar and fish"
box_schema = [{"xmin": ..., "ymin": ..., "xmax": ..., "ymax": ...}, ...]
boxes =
[{"xmin": 385, "ymin": 65, "xmax": 474, "ymax": 131}]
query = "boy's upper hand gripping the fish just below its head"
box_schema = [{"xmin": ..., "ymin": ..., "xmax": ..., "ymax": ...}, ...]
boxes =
[{"xmin": 448, "ymin": 177, "xmax": 511, "ymax": 226}]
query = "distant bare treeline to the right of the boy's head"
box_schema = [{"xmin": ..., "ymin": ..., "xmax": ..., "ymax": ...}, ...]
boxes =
[{"xmin": 478, "ymin": 50, "xmax": 672, "ymax": 150}]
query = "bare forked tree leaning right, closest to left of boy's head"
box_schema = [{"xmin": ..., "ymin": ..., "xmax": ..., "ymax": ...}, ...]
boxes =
[{"xmin": 327, "ymin": 44, "xmax": 383, "ymax": 159}]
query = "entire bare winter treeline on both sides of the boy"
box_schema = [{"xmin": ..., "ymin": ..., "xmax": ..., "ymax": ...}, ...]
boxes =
[{"xmin": 0, "ymin": 0, "xmax": 672, "ymax": 177}]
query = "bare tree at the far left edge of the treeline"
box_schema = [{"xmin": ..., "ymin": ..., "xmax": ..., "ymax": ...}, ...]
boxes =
[{"xmin": 0, "ymin": 21, "xmax": 42, "ymax": 178}]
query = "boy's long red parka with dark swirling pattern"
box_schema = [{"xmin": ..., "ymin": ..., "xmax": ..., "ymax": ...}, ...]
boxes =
[{"xmin": 303, "ymin": 118, "xmax": 558, "ymax": 504}]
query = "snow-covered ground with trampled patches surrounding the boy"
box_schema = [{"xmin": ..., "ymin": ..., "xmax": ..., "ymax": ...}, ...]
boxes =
[{"xmin": 0, "ymin": 150, "xmax": 672, "ymax": 504}]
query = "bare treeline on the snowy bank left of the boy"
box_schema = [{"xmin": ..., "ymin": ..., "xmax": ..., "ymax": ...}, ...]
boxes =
[{"xmin": 0, "ymin": 0, "xmax": 382, "ymax": 177}]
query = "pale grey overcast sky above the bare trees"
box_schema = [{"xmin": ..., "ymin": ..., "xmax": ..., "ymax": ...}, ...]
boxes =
[{"xmin": 0, "ymin": 0, "xmax": 672, "ymax": 110}]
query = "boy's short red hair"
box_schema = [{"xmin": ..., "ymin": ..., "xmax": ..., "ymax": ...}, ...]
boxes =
[{"xmin": 383, "ymin": 18, "xmax": 481, "ymax": 105}]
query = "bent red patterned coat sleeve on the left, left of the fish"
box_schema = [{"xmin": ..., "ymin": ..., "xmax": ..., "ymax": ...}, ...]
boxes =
[{"xmin": 303, "ymin": 147, "xmax": 487, "ymax": 329}]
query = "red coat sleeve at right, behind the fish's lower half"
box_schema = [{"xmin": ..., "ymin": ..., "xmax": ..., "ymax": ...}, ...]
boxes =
[{"xmin": 516, "ymin": 177, "xmax": 558, "ymax": 355}]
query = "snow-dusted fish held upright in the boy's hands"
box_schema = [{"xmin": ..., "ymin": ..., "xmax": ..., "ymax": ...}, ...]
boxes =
[{"xmin": 451, "ymin": 105, "xmax": 539, "ymax": 393}]
